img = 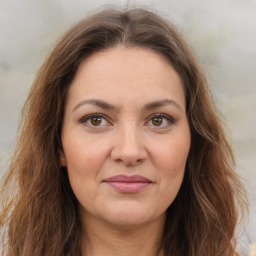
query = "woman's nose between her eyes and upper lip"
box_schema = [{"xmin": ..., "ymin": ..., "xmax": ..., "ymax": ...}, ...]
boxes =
[{"xmin": 111, "ymin": 124, "xmax": 147, "ymax": 166}]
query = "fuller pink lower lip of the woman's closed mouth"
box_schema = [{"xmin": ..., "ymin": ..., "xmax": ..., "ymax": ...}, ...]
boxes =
[{"xmin": 106, "ymin": 181, "xmax": 151, "ymax": 193}]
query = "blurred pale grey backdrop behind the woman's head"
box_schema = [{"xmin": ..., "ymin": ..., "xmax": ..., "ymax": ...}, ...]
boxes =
[{"xmin": 0, "ymin": 0, "xmax": 256, "ymax": 255}]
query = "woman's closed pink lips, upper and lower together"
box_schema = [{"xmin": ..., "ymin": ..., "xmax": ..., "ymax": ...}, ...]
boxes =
[{"xmin": 104, "ymin": 175, "xmax": 152, "ymax": 193}]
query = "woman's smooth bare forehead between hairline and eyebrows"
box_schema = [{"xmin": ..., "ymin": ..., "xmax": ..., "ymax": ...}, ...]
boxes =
[{"xmin": 68, "ymin": 46, "xmax": 185, "ymax": 109}]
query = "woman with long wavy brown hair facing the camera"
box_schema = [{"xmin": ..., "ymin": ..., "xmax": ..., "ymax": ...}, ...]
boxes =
[{"xmin": 1, "ymin": 9, "xmax": 246, "ymax": 256}]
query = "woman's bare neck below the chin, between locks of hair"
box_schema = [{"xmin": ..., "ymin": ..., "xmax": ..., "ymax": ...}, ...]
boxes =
[{"xmin": 81, "ymin": 212, "xmax": 165, "ymax": 256}]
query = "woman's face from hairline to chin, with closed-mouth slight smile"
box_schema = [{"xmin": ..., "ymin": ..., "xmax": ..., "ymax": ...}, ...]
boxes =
[{"xmin": 61, "ymin": 46, "xmax": 190, "ymax": 226}]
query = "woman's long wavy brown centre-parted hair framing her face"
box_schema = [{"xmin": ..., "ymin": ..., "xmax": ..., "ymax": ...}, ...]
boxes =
[{"xmin": 0, "ymin": 9, "xmax": 246, "ymax": 256}]
